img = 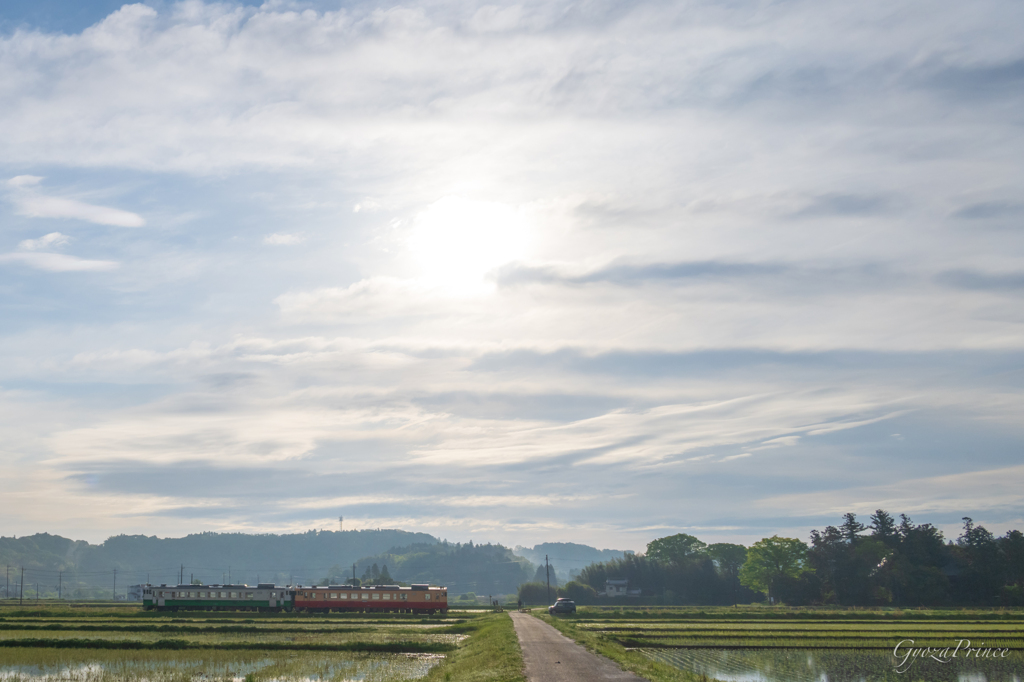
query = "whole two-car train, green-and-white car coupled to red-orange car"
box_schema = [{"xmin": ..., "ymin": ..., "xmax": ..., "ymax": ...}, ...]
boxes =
[{"xmin": 142, "ymin": 583, "xmax": 447, "ymax": 614}]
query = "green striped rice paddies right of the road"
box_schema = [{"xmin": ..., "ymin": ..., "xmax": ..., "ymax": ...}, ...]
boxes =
[{"xmin": 558, "ymin": 607, "xmax": 1024, "ymax": 682}]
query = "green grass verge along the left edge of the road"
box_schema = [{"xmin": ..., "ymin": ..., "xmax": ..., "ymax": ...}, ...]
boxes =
[{"xmin": 424, "ymin": 613, "xmax": 526, "ymax": 682}]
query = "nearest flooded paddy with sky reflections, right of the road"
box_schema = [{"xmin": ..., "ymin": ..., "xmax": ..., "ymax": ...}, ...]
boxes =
[{"xmin": 640, "ymin": 648, "xmax": 1024, "ymax": 682}]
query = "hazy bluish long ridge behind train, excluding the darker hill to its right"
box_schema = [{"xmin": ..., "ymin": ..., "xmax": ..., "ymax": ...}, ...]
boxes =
[{"xmin": 0, "ymin": 529, "xmax": 437, "ymax": 588}]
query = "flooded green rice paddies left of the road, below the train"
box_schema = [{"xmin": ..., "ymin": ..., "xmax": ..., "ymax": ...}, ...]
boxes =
[{"xmin": 0, "ymin": 606, "xmax": 483, "ymax": 682}]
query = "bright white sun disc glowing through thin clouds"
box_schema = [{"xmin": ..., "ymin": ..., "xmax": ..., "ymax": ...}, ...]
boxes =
[{"xmin": 409, "ymin": 197, "xmax": 529, "ymax": 293}]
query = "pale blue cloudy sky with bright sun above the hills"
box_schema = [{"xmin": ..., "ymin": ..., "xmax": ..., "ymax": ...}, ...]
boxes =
[{"xmin": 0, "ymin": 0, "xmax": 1024, "ymax": 551}]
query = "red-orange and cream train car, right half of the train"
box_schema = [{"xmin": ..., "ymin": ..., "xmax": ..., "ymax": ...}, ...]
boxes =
[{"xmin": 293, "ymin": 585, "xmax": 447, "ymax": 613}]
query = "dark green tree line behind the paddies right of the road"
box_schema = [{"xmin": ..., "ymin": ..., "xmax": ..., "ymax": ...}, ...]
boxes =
[{"xmin": 558, "ymin": 509, "xmax": 1024, "ymax": 606}]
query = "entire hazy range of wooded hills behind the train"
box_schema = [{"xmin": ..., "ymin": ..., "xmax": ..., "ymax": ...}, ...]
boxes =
[{"xmin": 0, "ymin": 529, "xmax": 624, "ymax": 598}]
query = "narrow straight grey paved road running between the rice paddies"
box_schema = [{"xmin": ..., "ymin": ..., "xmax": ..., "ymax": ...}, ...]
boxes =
[{"xmin": 509, "ymin": 611, "xmax": 643, "ymax": 682}]
